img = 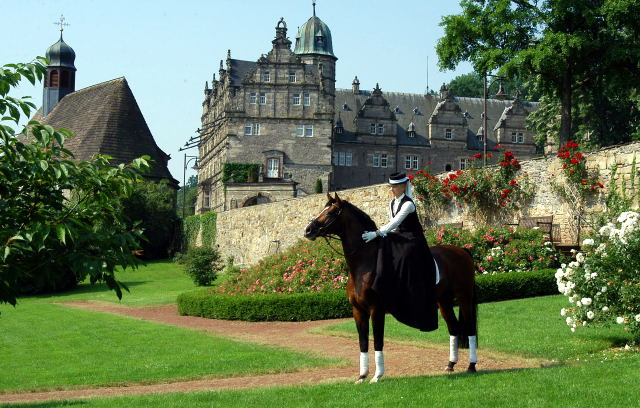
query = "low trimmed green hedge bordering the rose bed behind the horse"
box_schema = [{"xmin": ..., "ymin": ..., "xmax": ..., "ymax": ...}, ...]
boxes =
[{"xmin": 178, "ymin": 269, "xmax": 558, "ymax": 322}]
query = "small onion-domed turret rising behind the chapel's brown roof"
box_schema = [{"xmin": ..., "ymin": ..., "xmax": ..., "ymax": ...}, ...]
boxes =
[{"xmin": 42, "ymin": 30, "xmax": 76, "ymax": 117}]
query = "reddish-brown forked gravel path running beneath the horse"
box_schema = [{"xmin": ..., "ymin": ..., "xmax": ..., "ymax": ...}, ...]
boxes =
[{"xmin": 0, "ymin": 301, "xmax": 539, "ymax": 403}]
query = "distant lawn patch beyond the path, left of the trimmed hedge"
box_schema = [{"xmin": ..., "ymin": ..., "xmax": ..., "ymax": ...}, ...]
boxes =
[{"xmin": 18, "ymin": 261, "xmax": 197, "ymax": 306}]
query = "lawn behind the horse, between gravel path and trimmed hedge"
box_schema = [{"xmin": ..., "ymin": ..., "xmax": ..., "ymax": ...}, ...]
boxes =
[{"xmin": 323, "ymin": 295, "xmax": 631, "ymax": 361}]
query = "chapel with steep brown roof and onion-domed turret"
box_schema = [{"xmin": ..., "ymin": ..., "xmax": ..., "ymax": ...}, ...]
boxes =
[{"xmin": 33, "ymin": 31, "xmax": 178, "ymax": 189}]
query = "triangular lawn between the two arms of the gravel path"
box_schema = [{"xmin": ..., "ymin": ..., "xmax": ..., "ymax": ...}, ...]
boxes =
[{"xmin": 0, "ymin": 303, "xmax": 335, "ymax": 392}]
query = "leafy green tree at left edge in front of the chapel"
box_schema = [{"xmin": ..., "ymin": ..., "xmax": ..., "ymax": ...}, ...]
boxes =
[{"xmin": 0, "ymin": 58, "xmax": 149, "ymax": 305}]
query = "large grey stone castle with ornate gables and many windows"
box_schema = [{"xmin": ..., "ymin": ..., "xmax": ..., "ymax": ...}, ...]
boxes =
[{"xmin": 196, "ymin": 6, "xmax": 537, "ymax": 213}]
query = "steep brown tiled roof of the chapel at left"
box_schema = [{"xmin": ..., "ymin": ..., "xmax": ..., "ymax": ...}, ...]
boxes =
[{"xmin": 33, "ymin": 78, "xmax": 177, "ymax": 184}]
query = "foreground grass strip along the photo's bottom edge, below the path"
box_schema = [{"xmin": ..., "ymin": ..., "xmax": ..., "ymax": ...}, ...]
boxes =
[{"xmin": 6, "ymin": 353, "xmax": 640, "ymax": 408}]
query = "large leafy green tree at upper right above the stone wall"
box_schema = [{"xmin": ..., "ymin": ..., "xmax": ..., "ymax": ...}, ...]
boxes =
[{"xmin": 436, "ymin": 0, "xmax": 640, "ymax": 147}]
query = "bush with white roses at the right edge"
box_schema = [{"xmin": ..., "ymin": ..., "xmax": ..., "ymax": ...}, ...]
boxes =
[{"xmin": 555, "ymin": 211, "xmax": 640, "ymax": 343}]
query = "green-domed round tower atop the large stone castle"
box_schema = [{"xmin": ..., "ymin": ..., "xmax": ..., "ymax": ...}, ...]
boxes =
[{"xmin": 293, "ymin": 1, "xmax": 338, "ymax": 95}]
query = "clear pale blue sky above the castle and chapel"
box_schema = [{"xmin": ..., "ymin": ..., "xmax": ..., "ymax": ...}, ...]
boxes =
[{"xmin": 0, "ymin": 0, "xmax": 471, "ymax": 183}]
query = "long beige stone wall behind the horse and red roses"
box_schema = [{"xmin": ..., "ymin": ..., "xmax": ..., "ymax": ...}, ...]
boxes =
[{"xmin": 216, "ymin": 143, "xmax": 640, "ymax": 265}]
